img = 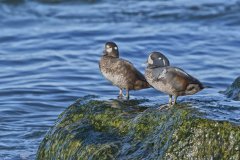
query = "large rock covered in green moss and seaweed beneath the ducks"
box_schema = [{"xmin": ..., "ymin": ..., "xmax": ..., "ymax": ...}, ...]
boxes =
[{"xmin": 37, "ymin": 97, "xmax": 240, "ymax": 160}]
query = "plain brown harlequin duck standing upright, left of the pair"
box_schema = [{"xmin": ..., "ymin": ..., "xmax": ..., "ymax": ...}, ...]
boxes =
[{"xmin": 99, "ymin": 42, "xmax": 150, "ymax": 99}]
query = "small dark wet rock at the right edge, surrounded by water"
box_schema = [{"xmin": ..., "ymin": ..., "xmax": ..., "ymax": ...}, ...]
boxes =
[{"xmin": 223, "ymin": 76, "xmax": 240, "ymax": 101}]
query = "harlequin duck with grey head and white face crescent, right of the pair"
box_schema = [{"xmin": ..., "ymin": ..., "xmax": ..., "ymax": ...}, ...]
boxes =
[{"xmin": 145, "ymin": 52, "xmax": 204, "ymax": 106}]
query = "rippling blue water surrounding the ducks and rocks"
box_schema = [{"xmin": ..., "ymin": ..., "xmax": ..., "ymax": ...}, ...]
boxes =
[{"xmin": 0, "ymin": 0, "xmax": 240, "ymax": 160}]
